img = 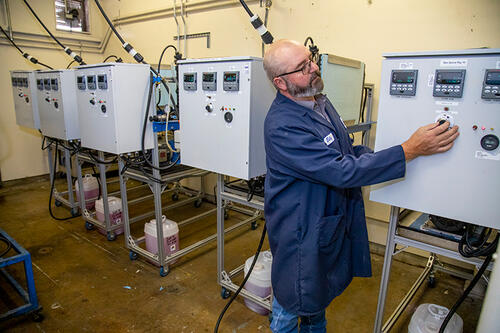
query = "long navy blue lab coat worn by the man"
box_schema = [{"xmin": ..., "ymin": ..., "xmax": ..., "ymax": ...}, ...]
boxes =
[{"xmin": 264, "ymin": 92, "xmax": 406, "ymax": 316}]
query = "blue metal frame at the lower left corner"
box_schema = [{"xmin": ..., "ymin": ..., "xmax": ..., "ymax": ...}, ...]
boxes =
[{"xmin": 0, "ymin": 229, "xmax": 42, "ymax": 320}]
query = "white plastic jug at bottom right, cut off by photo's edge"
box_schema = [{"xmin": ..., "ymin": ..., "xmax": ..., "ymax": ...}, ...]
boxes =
[{"xmin": 408, "ymin": 303, "xmax": 464, "ymax": 333}]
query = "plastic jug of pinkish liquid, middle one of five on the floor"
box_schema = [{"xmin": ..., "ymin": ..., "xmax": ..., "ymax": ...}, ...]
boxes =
[{"xmin": 144, "ymin": 215, "xmax": 179, "ymax": 255}]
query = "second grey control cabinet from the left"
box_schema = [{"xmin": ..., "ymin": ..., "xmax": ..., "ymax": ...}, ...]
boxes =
[{"xmin": 35, "ymin": 69, "xmax": 80, "ymax": 140}]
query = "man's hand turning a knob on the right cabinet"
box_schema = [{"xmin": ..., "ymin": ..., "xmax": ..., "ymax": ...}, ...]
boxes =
[{"xmin": 401, "ymin": 121, "xmax": 460, "ymax": 161}]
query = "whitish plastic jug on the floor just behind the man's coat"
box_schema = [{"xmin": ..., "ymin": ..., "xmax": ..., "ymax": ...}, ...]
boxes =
[{"xmin": 244, "ymin": 251, "xmax": 273, "ymax": 315}]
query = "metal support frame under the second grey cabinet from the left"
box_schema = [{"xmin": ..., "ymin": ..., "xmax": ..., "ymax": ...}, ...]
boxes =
[{"xmin": 47, "ymin": 142, "xmax": 79, "ymax": 215}]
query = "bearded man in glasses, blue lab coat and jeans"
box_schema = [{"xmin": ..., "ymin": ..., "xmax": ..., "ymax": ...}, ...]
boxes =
[{"xmin": 264, "ymin": 40, "xmax": 459, "ymax": 333}]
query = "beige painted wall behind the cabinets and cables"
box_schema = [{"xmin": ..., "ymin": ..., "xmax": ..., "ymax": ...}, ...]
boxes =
[{"xmin": 0, "ymin": 0, "xmax": 500, "ymax": 224}]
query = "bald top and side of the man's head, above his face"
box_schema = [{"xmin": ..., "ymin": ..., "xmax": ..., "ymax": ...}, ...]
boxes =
[{"xmin": 264, "ymin": 39, "xmax": 305, "ymax": 81}]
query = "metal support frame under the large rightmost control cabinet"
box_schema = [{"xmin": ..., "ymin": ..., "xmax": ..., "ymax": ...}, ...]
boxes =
[{"xmin": 373, "ymin": 206, "xmax": 493, "ymax": 333}]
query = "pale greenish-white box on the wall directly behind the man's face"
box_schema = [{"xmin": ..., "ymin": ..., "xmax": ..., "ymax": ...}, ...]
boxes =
[{"xmin": 320, "ymin": 53, "xmax": 365, "ymax": 126}]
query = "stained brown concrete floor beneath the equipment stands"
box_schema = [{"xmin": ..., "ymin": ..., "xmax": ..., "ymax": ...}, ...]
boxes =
[{"xmin": 0, "ymin": 177, "xmax": 482, "ymax": 333}]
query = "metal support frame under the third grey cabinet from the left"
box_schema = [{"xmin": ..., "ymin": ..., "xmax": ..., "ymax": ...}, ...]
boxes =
[{"xmin": 76, "ymin": 151, "xmax": 151, "ymax": 241}]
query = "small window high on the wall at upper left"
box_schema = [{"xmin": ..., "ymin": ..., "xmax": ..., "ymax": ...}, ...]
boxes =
[{"xmin": 54, "ymin": 0, "xmax": 89, "ymax": 32}]
